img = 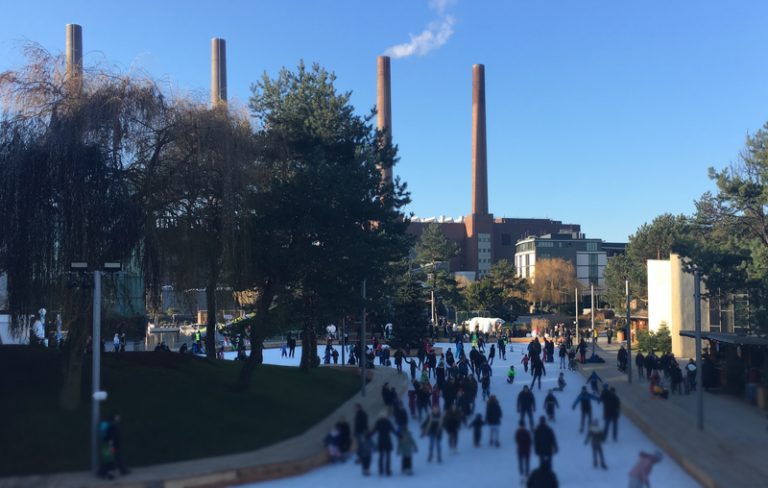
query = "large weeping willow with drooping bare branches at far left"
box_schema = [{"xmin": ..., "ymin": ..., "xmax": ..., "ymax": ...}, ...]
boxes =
[{"xmin": 0, "ymin": 47, "xmax": 174, "ymax": 409}]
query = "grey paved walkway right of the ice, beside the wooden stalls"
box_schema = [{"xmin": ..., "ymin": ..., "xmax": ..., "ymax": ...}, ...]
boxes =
[{"xmin": 582, "ymin": 344, "xmax": 768, "ymax": 488}]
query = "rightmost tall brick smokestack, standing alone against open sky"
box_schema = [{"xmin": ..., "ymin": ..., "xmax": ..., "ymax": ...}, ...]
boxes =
[{"xmin": 472, "ymin": 64, "xmax": 488, "ymax": 215}]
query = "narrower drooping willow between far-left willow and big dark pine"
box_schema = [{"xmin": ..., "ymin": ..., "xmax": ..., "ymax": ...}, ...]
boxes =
[{"xmin": 148, "ymin": 101, "xmax": 254, "ymax": 357}]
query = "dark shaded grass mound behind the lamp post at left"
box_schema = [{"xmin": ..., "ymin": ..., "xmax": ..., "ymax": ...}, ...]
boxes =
[{"xmin": 0, "ymin": 346, "xmax": 359, "ymax": 476}]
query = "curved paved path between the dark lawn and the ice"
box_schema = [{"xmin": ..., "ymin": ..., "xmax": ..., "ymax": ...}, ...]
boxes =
[{"xmin": 0, "ymin": 368, "xmax": 408, "ymax": 488}]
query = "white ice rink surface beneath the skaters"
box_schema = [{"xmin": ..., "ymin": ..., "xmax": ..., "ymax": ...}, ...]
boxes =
[{"xmin": 229, "ymin": 344, "xmax": 699, "ymax": 488}]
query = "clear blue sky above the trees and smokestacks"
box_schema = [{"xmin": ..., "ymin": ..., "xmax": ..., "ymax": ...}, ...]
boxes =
[{"xmin": 0, "ymin": 0, "xmax": 768, "ymax": 240}]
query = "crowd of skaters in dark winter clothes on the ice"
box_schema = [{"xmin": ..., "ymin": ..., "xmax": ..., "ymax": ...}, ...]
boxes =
[{"xmin": 316, "ymin": 328, "xmax": 660, "ymax": 487}]
